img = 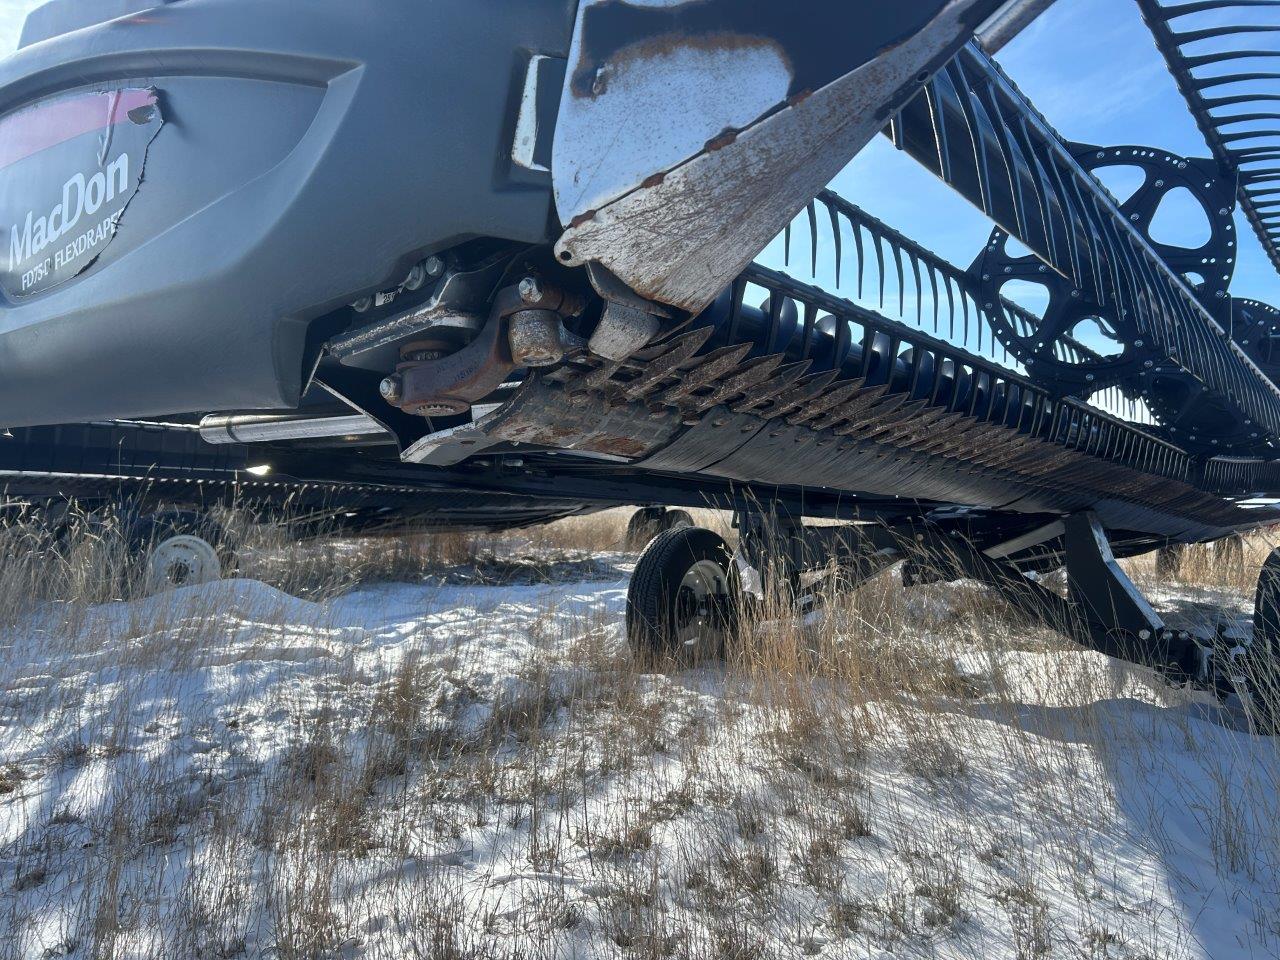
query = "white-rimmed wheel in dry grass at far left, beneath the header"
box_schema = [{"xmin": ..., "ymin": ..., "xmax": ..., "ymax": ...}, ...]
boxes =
[{"xmin": 128, "ymin": 509, "xmax": 230, "ymax": 596}]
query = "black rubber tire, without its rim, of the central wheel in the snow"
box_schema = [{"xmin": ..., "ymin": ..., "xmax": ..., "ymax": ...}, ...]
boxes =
[{"xmin": 627, "ymin": 526, "xmax": 737, "ymax": 659}]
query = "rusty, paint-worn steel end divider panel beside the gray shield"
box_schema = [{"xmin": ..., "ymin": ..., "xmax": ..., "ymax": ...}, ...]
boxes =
[{"xmin": 553, "ymin": 0, "xmax": 1001, "ymax": 312}]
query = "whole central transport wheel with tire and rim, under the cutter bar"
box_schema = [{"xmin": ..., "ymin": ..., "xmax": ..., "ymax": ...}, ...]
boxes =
[{"xmin": 627, "ymin": 526, "xmax": 736, "ymax": 660}]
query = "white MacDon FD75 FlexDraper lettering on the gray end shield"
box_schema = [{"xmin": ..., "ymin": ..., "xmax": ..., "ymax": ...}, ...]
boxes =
[{"xmin": 9, "ymin": 154, "xmax": 132, "ymax": 291}]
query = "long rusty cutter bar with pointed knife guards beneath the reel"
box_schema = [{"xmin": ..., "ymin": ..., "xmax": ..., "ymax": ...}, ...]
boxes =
[{"xmin": 453, "ymin": 259, "xmax": 1280, "ymax": 536}]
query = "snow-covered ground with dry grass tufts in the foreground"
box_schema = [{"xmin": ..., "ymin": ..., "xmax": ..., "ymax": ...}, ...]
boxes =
[{"xmin": 0, "ymin": 559, "xmax": 1280, "ymax": 960}]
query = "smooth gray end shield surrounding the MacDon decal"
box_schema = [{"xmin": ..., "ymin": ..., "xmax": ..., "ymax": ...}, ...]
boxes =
[{"xmin": 0, "ymin": 0, "xmax": 575, "ymax": 426}]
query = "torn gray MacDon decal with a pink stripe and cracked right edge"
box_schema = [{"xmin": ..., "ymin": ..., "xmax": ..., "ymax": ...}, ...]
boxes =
[{"xmin": 0, "ymin": 87, "xmax": 164, "ymax": 300}]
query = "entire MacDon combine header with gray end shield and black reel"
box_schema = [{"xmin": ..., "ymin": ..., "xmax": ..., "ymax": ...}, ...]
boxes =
[{"xmin": 0, "ymin": 0, "xmax": 1280, "ymax": 728}]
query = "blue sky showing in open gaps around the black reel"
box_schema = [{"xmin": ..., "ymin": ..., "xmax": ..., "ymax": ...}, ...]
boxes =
[{"xmin": 0, "ymin": 0, "xmax": 1280, "ymax": 303}]
